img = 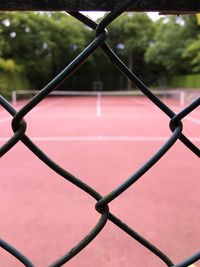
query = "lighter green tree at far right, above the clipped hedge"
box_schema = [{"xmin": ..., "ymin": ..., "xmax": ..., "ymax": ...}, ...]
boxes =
[{"xmin": 145, "ymin": 15, "xmax": 199, "ymax": 75}]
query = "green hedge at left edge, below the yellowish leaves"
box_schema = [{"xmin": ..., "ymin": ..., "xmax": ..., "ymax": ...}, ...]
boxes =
[{"xmin": 0, "ymin": 72, "xmax": 30, "ymax": 99}]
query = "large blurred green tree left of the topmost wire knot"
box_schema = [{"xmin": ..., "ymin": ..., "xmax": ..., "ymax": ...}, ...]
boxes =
[{"xmin": 0, "ymin": 12, "xmax": 85, "ymax": 89}]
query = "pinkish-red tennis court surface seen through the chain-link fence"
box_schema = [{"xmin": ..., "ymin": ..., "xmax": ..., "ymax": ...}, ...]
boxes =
[{"xmin": 0, "ymin": 97, "xmax": 200, "ymax": 267}]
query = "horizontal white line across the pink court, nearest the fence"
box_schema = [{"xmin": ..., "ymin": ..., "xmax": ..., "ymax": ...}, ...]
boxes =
[{"xmin": 0, "ymin": 136, "xmax": 200, "ymax": 142}]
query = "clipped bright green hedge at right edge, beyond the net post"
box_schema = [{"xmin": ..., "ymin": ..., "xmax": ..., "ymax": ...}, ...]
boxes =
[{"xmin": 171, "ymin": 74, "xmax": 200, "ymax": 88}]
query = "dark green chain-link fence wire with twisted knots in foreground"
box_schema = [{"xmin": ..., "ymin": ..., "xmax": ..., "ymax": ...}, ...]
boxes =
[{"xmin": 0, "ymin": 0, "xmax": 200, "ymax": 267}]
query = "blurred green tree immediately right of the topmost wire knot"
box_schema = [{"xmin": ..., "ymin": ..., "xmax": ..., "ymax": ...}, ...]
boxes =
[{"xmin": 109, "ymin": 13, "xmax": 154, "ymax": 89}]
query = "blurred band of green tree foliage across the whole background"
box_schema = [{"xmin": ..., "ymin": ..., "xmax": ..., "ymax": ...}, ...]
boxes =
[{"xmin": 0, "ymin": 12, "xmax": 200, "ymax": 98}]
